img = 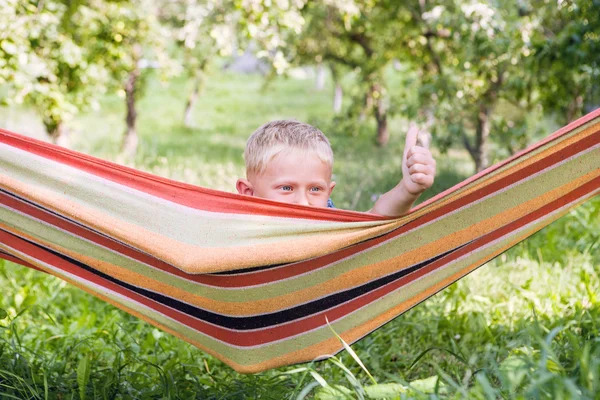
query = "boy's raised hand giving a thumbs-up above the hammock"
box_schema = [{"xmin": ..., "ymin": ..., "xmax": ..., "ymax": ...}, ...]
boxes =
[{"xmin": 400, "ymin": 124, "xmax": 436, "ymax": 196}]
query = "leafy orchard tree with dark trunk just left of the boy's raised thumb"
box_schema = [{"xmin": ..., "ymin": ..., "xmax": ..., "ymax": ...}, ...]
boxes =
[{"xmin": 292, "ymin": 0, "xmax": 407, "ymax": 145}]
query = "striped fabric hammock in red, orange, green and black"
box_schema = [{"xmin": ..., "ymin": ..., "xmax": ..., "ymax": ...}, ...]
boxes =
[{"xmin": 0, "ymin": 110, "xmax": 600, "ymax": 372}]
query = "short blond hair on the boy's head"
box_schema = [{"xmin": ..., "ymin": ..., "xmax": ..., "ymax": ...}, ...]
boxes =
[{"xmin": 244, "ymin": 120, "xmax": 333, "ymax": 176}]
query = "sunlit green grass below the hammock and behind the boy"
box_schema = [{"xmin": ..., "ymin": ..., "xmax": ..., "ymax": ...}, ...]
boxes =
[{"xmin": 0, "ymin": 73, "xmax": 600, "ymax": 399}]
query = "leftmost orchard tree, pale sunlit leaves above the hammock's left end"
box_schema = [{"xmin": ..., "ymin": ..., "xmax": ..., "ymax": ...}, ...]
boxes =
[{"xmin": 0, "ymin": 0, "xmax": 108, "ymax": 144}]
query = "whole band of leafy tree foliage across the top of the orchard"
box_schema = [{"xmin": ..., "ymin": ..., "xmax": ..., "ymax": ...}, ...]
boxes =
[{"xmin": 0, "ymin": 0, "xmax": 600, "ymax": 169}]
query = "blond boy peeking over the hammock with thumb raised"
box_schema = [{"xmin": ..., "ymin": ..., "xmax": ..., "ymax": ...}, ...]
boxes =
[{"xmin": 236, "ymin": 120, "xmax": 435, "ymax": 217}]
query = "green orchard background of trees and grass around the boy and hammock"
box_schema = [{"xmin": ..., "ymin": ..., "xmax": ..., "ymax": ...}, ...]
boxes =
[{"xmin": 0, "ymin": 0, "xmax": 600, "ymax": 399}]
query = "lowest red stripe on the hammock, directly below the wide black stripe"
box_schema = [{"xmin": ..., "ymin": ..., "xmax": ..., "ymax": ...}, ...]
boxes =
[{"xmin": 0, "ymin": 177, "xmax": 600, "ymax": 346}]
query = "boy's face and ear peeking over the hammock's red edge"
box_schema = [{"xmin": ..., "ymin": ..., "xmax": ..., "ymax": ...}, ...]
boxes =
[{"xmin": 236, "ymin": 150, "xmax": 335, "ymax": 207}]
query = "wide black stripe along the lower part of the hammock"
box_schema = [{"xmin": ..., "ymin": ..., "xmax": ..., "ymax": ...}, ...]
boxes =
[{"xmin": 0, "ymin": 229, "xmax": 465, "ymax": 331}]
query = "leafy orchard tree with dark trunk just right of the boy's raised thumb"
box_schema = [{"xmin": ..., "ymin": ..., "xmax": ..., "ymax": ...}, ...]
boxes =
[{"xmin": 404, "ymin": 0, "xmax": 540, "ymax": 171}]
